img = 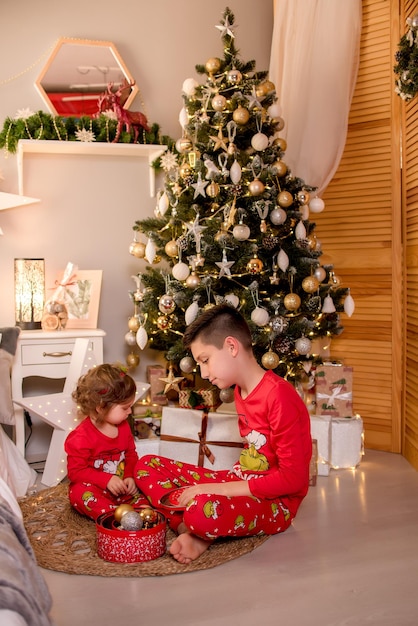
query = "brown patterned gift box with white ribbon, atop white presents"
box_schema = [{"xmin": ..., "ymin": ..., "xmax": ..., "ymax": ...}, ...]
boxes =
[{"xmin": 315, "ymin": 363, "xmax": 353, "ymax": 417}]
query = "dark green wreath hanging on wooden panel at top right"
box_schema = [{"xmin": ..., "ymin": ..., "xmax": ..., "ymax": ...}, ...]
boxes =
[{"xmin": 393, "ymin": 14, "xmax": 418, "ymax": 102}]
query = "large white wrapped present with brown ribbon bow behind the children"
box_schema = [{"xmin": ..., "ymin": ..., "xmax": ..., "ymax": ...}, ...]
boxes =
[{"xmin": 160, "ymin": 407, "xmax": 244, "ymax": 470}]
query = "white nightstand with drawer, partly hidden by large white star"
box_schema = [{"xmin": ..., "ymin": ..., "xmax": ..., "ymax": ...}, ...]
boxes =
[{"xmin": 12, "ymin": 329, "xmax": 106, "ymax": 456}]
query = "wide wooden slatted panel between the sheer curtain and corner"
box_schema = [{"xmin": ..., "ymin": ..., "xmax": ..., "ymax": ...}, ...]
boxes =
[{"xmin": 315, "ymin": 0, "xmax": 402, "ymax": 452}]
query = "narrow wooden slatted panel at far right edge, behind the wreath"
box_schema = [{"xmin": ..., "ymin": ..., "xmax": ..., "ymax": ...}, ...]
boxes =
[{"xmin": 401, "ymin": 0, "xmax": 418, "ymax": 469}]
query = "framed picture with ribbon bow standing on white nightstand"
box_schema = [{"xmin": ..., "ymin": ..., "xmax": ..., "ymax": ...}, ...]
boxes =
[{"xmin": 60, "ymin": 270, "xmax": 103, "ymax": 329}]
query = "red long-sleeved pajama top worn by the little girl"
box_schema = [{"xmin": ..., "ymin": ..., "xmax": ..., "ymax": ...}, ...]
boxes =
[{"xmin": 65, "ymin": 417, "xmax": 138, "ymax": 489}]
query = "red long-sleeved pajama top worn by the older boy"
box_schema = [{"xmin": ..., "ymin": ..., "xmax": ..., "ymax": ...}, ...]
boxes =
[{"xmin": 234, "ymin": 371, "xmax": 312, "ymax": 517}]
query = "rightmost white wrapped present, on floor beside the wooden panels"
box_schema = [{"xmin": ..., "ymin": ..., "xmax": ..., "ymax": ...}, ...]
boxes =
[{"xmin": 331, "ymin": 415, "xmax": 364, "ymax": 469}]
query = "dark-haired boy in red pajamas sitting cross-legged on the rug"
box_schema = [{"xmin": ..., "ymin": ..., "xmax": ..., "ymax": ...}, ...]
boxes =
[{"xmin": 135, "ymin": 305, "xmax": 312, "ymax": 564}]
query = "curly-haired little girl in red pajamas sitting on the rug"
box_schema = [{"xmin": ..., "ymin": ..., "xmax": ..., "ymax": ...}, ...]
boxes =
[{"xmin": 65, "ymin": 364, "xmax": 147, "ymax": 520}]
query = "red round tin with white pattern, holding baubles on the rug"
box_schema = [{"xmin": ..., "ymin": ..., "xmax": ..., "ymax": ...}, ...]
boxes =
[{"xmin": 96, "ymin": 513, "xmax": 167, "ymax": 563}]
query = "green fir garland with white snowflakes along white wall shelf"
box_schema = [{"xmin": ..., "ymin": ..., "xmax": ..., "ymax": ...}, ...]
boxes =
[{"xmin": 0, "ymin": 111, "xmax": 174, "ymax": 168}]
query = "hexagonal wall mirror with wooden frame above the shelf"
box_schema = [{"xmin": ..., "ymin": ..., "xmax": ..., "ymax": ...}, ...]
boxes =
[{"xmin": 35, "ymin": 37, "xmax": 138, "ymax": 117}]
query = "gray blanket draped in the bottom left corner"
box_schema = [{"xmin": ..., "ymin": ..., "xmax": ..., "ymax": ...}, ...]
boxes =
[{"xmin": 0, "ymin": 500, "xmax": 52, "ymax": 626}]
